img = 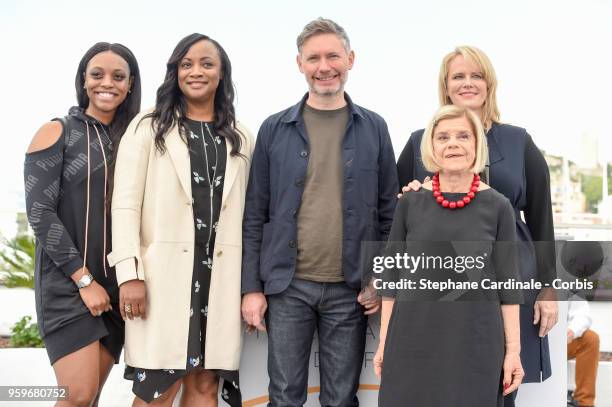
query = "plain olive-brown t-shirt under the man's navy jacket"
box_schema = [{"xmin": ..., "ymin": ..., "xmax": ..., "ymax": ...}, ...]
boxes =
[{"xmin": 295, "ymin": 104, "xmax": 349, "ymax": 282}]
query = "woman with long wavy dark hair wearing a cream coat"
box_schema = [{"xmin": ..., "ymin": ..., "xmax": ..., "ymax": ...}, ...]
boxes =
[{"xmin": 108, "ymin": 34, "xmax": 253, "ymax": 406}]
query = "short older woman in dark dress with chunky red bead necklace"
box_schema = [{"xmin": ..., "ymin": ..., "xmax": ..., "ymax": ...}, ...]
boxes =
[{"xmin": 374, "ymin": 106, "xmax": 524, "ymax": 407}]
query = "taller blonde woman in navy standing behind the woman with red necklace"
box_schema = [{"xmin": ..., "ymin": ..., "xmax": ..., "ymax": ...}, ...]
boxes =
[{"xmin": 397, "ymin": 46, "xmax": 558, "ymax": 407}]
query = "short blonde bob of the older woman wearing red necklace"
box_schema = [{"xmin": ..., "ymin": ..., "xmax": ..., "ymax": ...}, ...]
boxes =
[{"xmin": 421, "ymin": 105, "xmax": 489, "ymax": 174}]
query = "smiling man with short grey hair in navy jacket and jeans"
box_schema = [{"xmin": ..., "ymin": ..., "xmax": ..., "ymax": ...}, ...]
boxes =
[{"xmin": 242, "ymin": 18, "xmax": 399, "ymax": 406}]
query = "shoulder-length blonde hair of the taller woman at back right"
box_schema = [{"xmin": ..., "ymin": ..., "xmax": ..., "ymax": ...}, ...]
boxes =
[{"xmin": 438, "ymin": 45, "xmax": 499, "ymax": 128}]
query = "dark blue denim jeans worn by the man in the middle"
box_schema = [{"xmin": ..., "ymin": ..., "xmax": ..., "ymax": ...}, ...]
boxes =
[{"xmin": 266, "ymin": 279, "xmax": 367, "ymax": 407}]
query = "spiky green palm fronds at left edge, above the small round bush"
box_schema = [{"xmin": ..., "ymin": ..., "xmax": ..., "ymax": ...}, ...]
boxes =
[{"xmin": 0, "ymin": 234, "xmax": 35, "ymax": 288}]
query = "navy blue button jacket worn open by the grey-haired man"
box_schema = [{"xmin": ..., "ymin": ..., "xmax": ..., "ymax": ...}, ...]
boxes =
[{"xmin": 242, "ymin": 94, "xmax": 399, "ymax": 294}]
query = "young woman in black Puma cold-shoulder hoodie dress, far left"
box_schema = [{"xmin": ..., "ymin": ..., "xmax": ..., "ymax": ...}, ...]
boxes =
[{"xmin": 24, "ymin": 42, "xmax": 140, "ymax": 406}]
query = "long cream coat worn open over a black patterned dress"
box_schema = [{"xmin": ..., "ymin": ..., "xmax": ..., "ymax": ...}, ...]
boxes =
[{"xmin": 108, "ymin": 112, "xmax": 253, "ymax": 370}]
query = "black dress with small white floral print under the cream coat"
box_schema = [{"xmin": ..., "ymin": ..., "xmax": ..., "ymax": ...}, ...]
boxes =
[{"xmin": 126, "ymin": 119, "xmax": 241, "ymax": 406}]
